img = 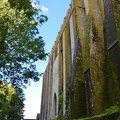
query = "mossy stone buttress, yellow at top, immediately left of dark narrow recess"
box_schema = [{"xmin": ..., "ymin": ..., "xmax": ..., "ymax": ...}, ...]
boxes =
[{"xmin": 71, "ymin": 0, "xmax": 86, "ymax": 119}]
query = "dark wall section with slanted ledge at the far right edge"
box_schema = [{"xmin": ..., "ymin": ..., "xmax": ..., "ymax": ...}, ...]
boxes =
[{"xmin": 103, "ymin": 0, "xmax": 120, "ymax": 106}]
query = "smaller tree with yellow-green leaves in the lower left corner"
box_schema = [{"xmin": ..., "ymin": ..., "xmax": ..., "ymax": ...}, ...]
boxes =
[{"xmin": 0, "ymin": 83, "xmax": 25, "ymax": 120}]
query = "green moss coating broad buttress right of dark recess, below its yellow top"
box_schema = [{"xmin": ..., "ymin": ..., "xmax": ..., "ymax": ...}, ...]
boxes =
[{"xmin": 90, "ymin": 18, "xmax": 105, "ymax": 114}]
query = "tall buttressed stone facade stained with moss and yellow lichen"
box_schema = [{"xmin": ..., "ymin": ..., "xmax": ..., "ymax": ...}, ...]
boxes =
[{"xmin": 40, "ymin": 0, "xmax": 120, "ymax": 120}]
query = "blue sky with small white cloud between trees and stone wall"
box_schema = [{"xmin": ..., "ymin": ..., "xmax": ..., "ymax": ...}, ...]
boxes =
[{"xmin": 24, "ymin": 0, "xmax": 71, "ymax": 119}]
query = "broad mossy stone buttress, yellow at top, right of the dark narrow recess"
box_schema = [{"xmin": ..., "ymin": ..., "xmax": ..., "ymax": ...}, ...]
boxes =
[{"xmin": 88, "ymin": 0, "xmax": 106, "ymax": 114}]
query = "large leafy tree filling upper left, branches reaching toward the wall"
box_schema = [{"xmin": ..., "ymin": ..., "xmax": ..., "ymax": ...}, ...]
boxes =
[{"xmin": 0, "ymin": 0, "xmax": 48, "ymax": 87}]
